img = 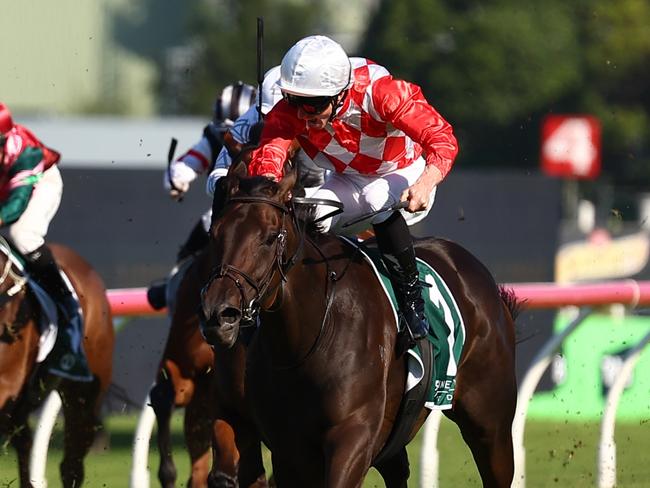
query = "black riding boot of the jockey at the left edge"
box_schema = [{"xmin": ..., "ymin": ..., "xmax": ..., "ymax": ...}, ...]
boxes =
[{"xmin": 25, "ymin": 245, "xmax": 93, "ymax": 381}]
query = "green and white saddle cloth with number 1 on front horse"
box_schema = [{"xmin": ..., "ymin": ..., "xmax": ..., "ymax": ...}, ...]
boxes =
[{"xmin": 343, "ymin": 237, "xmax": 465, "ymax": 410}]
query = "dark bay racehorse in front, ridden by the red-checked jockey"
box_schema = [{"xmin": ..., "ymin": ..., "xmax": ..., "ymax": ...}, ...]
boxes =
[{"xmin": 202, "ymin": 161, "xmax": 520, "ymax": 488}]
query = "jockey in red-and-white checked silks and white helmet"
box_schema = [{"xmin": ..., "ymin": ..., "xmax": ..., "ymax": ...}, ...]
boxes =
[{"xmin": 249, "ymin": 36, "xmax": 458, "ymax": 341}]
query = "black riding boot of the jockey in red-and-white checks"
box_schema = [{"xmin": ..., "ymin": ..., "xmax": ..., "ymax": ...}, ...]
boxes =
[{"xmin": 373, "ymin": 212, "xmax": 429, "ymax": 340}]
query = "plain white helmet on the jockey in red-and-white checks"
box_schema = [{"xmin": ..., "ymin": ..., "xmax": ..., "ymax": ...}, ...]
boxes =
[{"xmin": 278, "ymin": 36, "xmax": 351, "ymax": 97}]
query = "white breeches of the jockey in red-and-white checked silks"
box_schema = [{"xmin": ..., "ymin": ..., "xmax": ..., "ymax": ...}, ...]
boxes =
[{"xmin": 311, "ymin": 158, "xmax": 436, "ymax": 235}]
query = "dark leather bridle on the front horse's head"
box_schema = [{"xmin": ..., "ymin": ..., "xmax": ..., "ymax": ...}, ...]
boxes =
[{"xmin": 201, "ymin": 196, "xmax": 300, "ymax": 327}]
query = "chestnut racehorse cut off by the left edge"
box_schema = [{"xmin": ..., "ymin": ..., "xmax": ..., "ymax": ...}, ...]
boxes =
[{"xmin": 0, "ymin": 244, "xmax": 114, "ymax": 488}]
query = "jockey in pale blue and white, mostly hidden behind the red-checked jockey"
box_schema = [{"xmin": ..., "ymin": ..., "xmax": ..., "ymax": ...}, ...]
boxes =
[{"xmin": 206, "ymin": 66, "xmax": 325, "ymax": 200}]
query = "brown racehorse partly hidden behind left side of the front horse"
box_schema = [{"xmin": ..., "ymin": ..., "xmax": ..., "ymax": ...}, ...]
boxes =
[{"xmin": 150, "ymin": 248, "xmax": 268, "ymax": 488}]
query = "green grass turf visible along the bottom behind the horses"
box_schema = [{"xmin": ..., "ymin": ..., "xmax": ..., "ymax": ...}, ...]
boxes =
[{"xmin": 0, "ymin": 414, "xmax": 650, "ymax": 488}]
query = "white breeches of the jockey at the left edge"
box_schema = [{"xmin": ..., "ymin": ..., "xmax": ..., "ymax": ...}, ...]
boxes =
[{"xmin": 9, "ymin": 165, "xmax": 63, "ymax": 254}]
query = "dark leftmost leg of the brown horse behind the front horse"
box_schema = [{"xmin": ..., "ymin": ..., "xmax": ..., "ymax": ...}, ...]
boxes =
[{"xmin": 149, "ymin": 374, "xmax": 176, "ymax": 488}]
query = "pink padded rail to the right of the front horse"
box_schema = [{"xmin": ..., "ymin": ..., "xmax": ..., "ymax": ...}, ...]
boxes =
[{"xmin": 504, "ymin": 280, "xmax": 650, "ymax": 308}]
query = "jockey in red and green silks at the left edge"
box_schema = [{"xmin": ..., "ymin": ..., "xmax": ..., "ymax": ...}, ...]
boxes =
[{"xmin": 0, "ymin": 103, "xmax": 93, "ymax": 381}]
